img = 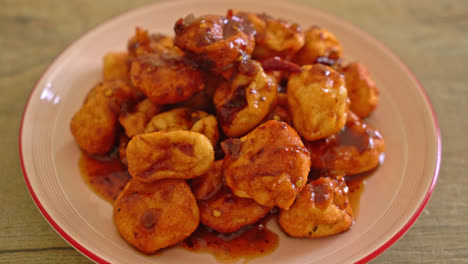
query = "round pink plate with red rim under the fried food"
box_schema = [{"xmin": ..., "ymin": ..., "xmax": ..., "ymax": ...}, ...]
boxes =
[{"xmin": 20, "ymin": 0, "xmax": 441, "ymax": 263}]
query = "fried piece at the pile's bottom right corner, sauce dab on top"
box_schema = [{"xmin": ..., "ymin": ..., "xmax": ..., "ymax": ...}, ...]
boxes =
[{"xmin": 279, "ymin": 178, "xmax": 353, "ymax": 238}]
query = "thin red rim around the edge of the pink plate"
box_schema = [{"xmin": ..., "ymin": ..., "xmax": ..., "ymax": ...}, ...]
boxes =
[{"xmin": 19, "ymin": 1, "xmax": 442, "ymax": 263}]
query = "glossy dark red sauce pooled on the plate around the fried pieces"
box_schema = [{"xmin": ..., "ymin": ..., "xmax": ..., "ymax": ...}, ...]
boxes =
[{"xmin": 79, "ymin": 145, "xmax": 375, "ymax": 261}]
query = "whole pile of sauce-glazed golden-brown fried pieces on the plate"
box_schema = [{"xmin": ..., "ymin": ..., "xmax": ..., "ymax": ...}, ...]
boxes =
[{"xmin": 71, "ymin": 10, "xmax": 385, "ymax": 253}]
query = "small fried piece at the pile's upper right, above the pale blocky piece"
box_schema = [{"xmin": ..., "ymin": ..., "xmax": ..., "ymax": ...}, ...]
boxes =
[{"xmin": 293, "ymin": 26, "xmax": 343, "ymax": 65}]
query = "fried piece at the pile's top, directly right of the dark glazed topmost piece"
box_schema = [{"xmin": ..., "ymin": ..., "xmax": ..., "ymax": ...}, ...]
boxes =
[{"xmin": 234, "ymin": 11, "xmax": 305, "ymax": 60}]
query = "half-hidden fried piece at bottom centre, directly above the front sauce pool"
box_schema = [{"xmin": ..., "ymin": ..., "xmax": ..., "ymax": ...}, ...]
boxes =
[{"xmin": 197, "ymin": 187, "xmax": 272, "ymax": 233}]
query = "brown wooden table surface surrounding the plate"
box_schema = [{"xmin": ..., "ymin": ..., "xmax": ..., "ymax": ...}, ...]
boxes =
[{"xmin": 0, "ymin": 0, "xmax": 468, "ymax": 263}]
